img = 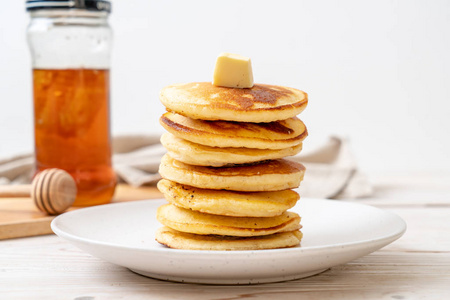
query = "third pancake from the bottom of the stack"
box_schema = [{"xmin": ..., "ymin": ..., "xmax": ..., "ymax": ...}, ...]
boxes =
[{"xmin": 158, "ymin": 179, "xmax": 300, "ymax": 217}]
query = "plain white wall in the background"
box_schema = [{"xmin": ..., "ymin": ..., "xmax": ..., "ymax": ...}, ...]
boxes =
[{"xmin": 0, "ymin": 0, "xmax": 450, "ymax": 171}]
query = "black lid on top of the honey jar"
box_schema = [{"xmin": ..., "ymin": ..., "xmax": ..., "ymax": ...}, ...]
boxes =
[{"xmin": 25, "ymin": 0, "xmax": 111, "ymax": 12}]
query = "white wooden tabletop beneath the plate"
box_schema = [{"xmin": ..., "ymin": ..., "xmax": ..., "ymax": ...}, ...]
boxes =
[{"xmin": 0, "ymin": 173, "xmax": 450, "ymax": 300}]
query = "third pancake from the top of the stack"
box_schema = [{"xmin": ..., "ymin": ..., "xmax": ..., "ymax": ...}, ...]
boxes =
[{"xmin": 161, "ymin": 132, "xmax": 302, "ymax": 167}]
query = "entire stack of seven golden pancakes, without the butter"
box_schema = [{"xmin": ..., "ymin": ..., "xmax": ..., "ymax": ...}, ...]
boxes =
[{"xmin": 156, "ymin": 82, "xmax": 308, "ymax": 250}]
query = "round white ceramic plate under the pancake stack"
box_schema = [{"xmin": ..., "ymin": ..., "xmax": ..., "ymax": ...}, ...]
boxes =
[{"xmin": 52, "ymin": 198, "xmax": 406, "ymax": 284}]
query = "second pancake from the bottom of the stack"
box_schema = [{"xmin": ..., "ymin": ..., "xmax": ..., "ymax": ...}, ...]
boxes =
[{"xmin": 156, "ymin": 204, "xmax": 301, "ymax": 236}]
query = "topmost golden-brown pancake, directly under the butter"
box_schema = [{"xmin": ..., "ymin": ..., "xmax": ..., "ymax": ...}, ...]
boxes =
[{"xmin": 160, "ymin": 82, "xmax": 308, "ymax": 123}]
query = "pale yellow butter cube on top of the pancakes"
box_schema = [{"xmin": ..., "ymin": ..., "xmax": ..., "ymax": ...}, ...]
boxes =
[{"xmin": 212, "ymin": 53, "xmax": 253, "ymax": 88}]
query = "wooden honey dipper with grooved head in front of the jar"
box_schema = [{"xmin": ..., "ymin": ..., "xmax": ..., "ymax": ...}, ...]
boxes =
[{"xmin": 0, "ymin": 169, "xmax": 77, "ymax": 215}]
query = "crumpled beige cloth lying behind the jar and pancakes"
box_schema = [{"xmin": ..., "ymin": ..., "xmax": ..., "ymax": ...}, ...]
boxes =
[{"xmin": 0, "ymin": 135, "xmax": 372, "ymax": 199}]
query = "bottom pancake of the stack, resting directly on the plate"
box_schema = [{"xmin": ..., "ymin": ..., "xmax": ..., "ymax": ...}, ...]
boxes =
[{"xmin": 155, "ymin": 227, "xmax": 303, "ymax": 251}]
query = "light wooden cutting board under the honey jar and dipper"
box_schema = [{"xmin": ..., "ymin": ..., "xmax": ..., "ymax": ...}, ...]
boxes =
[{"xmin": 0, "ymin": 184, "xmax": 162, "ymax": 240}]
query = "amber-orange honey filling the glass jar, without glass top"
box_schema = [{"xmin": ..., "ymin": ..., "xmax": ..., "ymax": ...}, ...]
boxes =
[{"xmin": 33, "ymin": 69, "xmax": 116, "ymax": 206}]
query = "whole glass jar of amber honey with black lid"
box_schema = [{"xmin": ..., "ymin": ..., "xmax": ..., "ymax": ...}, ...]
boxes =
[{"xmin": 26, "ymin": 0, "xmax": 116, "ymax": 206}]
